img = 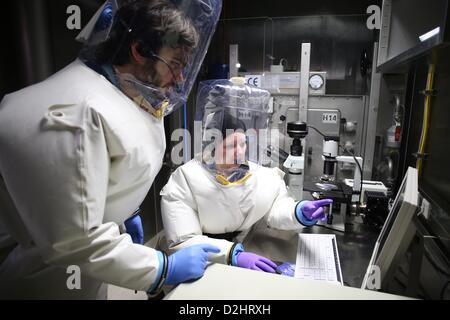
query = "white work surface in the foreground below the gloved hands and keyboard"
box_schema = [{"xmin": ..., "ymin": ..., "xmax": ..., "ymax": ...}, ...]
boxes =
[{"xmin": 164, "ymin": 264, "xmax": 409, "ymax": 300}]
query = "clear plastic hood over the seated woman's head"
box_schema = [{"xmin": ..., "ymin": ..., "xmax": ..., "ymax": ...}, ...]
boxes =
[{"xmin": 196, "ymin": 80, "xmax": 270, "ymax": 185}]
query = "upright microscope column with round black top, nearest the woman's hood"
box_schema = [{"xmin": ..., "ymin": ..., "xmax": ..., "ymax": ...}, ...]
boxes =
[{"xmin": 283, "ymin": 121, "xmax": 308, "ymax": 201}]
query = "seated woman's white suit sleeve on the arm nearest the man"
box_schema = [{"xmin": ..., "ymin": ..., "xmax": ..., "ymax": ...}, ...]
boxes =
[{"xmin": 161, "ymin": 163, "xmax": 234, "ymax": 264}]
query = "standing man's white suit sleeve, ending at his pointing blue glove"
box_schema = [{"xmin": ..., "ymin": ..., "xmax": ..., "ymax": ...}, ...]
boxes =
[{"xmin": 0, "ymin": 103, "xmax": 160, "ymax": 291}]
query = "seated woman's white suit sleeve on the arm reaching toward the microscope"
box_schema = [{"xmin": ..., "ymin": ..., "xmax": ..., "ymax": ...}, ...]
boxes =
[{"xmin": 266, "ymin": 168, "xmax": 303, "ymax": 230}]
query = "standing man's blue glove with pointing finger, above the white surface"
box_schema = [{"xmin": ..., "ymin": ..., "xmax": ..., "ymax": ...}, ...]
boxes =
[{"xmin": 165, "ymin": 244, "xmax": 220, "ymax": 285}]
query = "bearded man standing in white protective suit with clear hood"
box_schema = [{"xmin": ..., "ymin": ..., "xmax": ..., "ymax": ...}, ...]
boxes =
[{"xmin": 0, "ymin": 0, "xmax": 221, "ymax": 299}]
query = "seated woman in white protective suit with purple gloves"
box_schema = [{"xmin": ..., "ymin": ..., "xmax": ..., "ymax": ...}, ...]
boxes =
[{"xmin": 161, "ymin": 79, "xmax": 332, "ymax": 273}]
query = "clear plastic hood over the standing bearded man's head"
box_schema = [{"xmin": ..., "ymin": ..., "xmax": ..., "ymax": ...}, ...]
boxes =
[{"xmin": 77, "ymin": 0, "xmax": 222, "ymax": 118}]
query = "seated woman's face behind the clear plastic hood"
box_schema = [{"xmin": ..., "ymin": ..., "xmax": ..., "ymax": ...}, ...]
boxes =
[{"xmin": 214, "ymin": 132, "xmax": 247, "ymax": 170}]
